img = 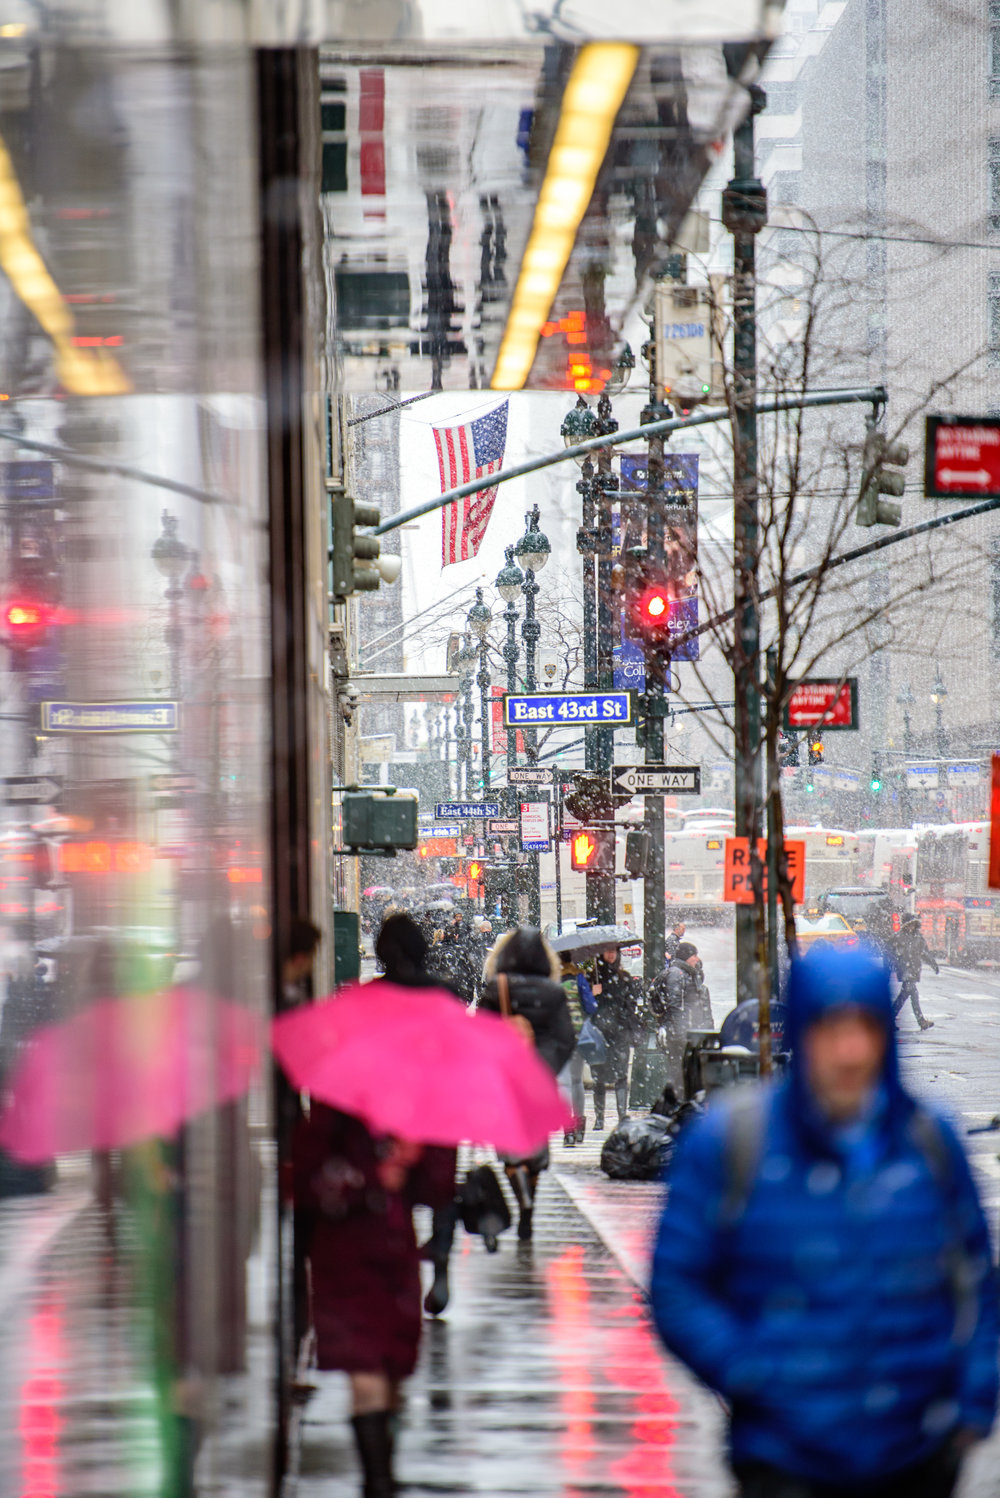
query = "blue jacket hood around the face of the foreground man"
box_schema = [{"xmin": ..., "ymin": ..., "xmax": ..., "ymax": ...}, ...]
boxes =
[{"xmin": 786, "ymin": 942, "xmax": 909, "ymax": 1118}]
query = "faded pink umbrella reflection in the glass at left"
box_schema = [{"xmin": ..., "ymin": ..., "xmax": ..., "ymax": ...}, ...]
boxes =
[{"xmin": 0, "ymin": 987, "xmax": 262, "ymax": 1164}]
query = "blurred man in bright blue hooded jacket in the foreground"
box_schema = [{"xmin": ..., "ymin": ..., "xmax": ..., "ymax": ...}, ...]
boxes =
[{"xmin": 651, "ymin": 947, "xmax": 999, "ymax": 1498}]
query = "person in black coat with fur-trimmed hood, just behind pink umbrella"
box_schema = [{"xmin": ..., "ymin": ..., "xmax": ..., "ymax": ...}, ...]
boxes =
[{"xmin": 479, "ymin": 926, "xmax": 576, "ymax": 1239}]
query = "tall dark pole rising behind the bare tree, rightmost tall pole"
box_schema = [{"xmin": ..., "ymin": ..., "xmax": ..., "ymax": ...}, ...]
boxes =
[{"xmin": 722, "ymin": 67, "xmax": 771, "ymax": 1006}]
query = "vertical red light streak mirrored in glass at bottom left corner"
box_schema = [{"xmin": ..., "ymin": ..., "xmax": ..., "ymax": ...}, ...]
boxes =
[{"xmin": 18, "ymin": 1296, "xmax": 64, "ymax": 1498}]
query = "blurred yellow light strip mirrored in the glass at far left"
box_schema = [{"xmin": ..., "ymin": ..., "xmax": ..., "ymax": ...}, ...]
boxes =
[{"xmin": 0, "ymin": 141, "xmax": 132, "ymax": 395}]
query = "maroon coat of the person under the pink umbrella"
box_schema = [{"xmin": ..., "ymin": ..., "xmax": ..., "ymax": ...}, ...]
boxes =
[{"xmin": 295, "ymin": 1103, "xmax": 455, "ymax": 1380}]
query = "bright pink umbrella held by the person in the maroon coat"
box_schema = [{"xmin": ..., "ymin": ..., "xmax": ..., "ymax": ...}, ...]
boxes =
[{"xmin": 271, "ymin": 980, "xmax": 573, "ymax": 1156}]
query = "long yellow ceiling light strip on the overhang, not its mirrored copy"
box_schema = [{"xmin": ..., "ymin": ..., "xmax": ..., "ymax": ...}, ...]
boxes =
[{"xmin": 491, "ymin": 42, "xmax": 639, "ymax": 389}]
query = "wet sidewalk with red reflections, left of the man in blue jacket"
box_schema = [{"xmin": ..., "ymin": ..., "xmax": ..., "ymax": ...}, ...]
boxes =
[{"xmin": 295, "ymin": 1143, "xmax": 731, "ymax": 1498}]
